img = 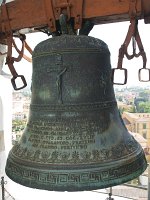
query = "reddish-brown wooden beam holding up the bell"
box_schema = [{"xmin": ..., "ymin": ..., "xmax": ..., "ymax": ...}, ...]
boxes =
[{"xmin": 0, "ymin": 0, "xmax": 150, "ymax": 35}]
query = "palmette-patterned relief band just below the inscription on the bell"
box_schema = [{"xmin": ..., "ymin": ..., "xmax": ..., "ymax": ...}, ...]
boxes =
[{"xmin": 11, "ymin": 140, "xmax": 140, "ymax": 168}]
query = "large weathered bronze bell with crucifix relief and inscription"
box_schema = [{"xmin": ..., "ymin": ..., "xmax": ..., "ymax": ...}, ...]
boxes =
[{"xmin": 6, "ymin": 35, "xmax": 147, "ymax": 191}]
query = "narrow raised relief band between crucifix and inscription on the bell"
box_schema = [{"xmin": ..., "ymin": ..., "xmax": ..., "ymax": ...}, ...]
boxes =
[{"xmin": 30, "ymin": 101, "xmax": 117, "ymax": 112}]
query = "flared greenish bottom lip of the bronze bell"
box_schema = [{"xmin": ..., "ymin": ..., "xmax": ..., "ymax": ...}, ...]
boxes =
[{"xmin": 6, "ymin": 149, "xmax": 147, "ymax": 192}]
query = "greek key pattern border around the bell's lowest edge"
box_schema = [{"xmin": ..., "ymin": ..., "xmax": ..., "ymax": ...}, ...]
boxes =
[{"xmin": 6, "ymin": 152, "xmax": 147, "ymax": 191}]
